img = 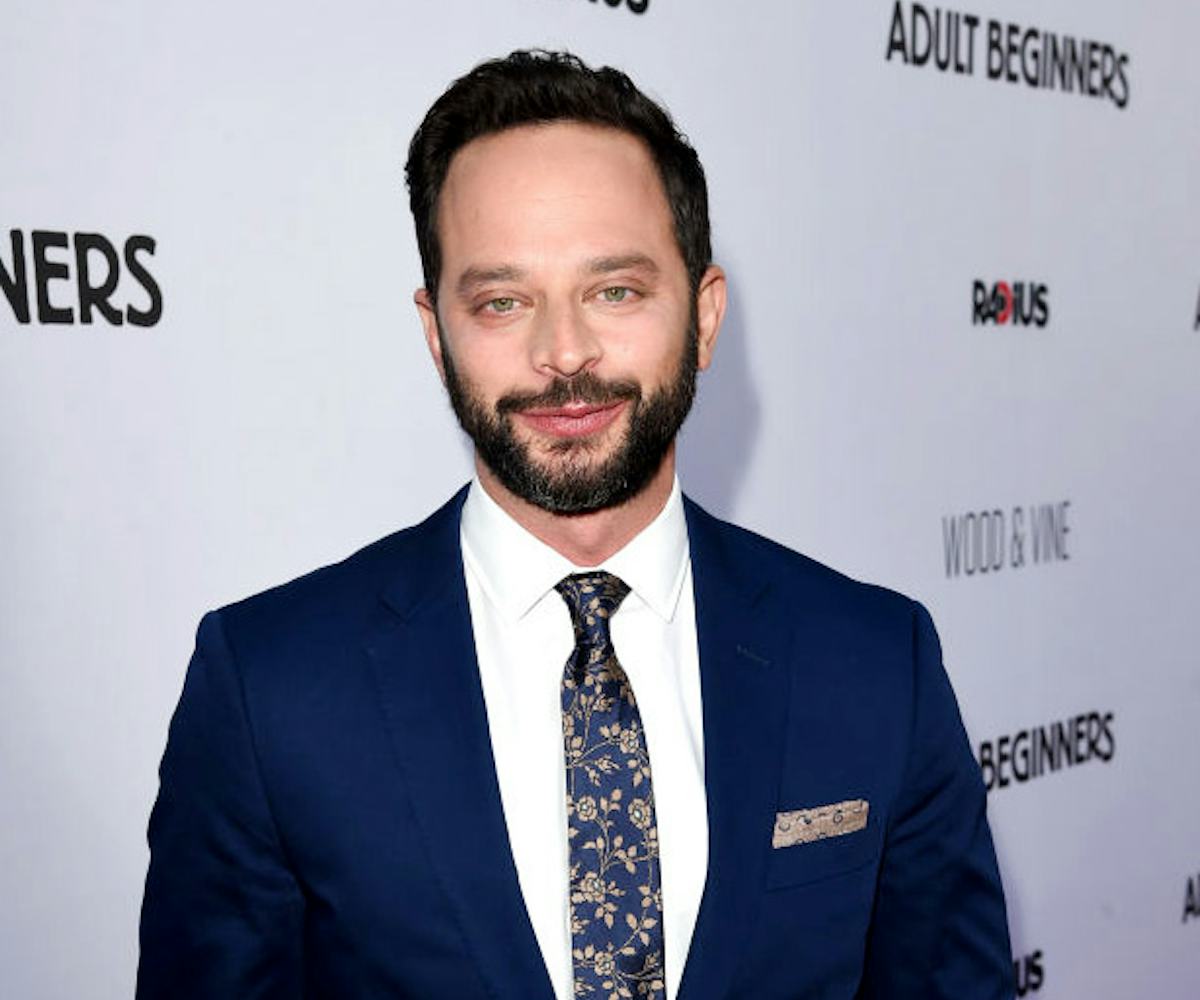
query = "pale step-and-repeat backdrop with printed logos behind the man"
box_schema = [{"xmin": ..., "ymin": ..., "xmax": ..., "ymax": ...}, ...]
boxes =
[{"xmin": 0, "ymin": 0, "xmax": 1200, "ymax": 1000}]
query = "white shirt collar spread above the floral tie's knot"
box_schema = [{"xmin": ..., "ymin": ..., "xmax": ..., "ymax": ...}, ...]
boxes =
[{"xmin": 461, "ymin": 478, "xmax": 688, "ymax": 622}]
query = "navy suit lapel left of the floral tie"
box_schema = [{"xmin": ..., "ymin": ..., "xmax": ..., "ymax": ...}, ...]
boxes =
[{"xmin": 367, "ymin": 491, "xmax": 553, "ymax": 1000}]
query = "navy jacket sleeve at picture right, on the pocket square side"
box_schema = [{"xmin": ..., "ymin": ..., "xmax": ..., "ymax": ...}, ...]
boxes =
[{"xmin": 859, "ymin": 605, "xmax": 1015, "ymax": 1000}]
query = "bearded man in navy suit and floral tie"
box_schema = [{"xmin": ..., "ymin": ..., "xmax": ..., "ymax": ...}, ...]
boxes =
[{"xmin": 139, "ymin": 53, "xmax": 1012, "ymax": 1000}]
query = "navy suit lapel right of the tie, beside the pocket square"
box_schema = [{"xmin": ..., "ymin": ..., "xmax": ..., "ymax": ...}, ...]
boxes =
[{"xmin": 679, "ymin": 501, "xmax": 791, "ymax": 1000}]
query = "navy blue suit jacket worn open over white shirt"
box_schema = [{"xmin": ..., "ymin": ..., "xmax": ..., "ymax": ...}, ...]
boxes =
[{"xmin": 138, "ymin": 493, "xmax": 1013, "ymax": 1000}]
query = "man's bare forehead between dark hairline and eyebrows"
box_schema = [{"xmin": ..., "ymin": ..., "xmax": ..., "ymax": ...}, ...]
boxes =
[{"xmin": 438, "ymin": 122, "xmax": 683, "ymax": 277}]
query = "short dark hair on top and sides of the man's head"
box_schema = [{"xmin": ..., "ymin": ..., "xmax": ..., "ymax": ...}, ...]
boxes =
[{"xmin": 404, "ymin": 49, "xmax": 713, "ymax": 304}]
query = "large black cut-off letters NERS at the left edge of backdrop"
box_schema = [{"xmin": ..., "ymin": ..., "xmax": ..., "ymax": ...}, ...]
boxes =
[{"xmin": 0, "ymin": 229, "xmax": 162, "ymax": 327}]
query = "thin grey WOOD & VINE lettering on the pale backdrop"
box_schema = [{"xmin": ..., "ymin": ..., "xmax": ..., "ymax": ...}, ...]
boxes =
[{"xmin": 942, "ymin": 499, "xmax": 1070, "ymax": 577}]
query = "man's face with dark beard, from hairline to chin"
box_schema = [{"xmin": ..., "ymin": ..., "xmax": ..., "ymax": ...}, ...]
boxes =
[{"xmin": 418, "ymin": 124, "xmax": 715, "ymax": 514}]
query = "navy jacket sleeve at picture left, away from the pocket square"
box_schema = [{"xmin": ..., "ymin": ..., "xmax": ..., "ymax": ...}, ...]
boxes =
[{"xmin": 137, "ymin": 612, "xmax": 304, "ymax": 1000}]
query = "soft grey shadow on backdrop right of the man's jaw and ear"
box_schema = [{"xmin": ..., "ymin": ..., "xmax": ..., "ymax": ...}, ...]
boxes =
[{"xmin": 679, "ymin": 261, "xmax": 761, "ymax": 519}]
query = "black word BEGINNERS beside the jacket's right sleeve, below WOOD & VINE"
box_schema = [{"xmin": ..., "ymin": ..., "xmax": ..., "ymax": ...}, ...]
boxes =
[{"xmin": 979, "ymin": 712, "xmax": 1117, "ymax": 791}]
